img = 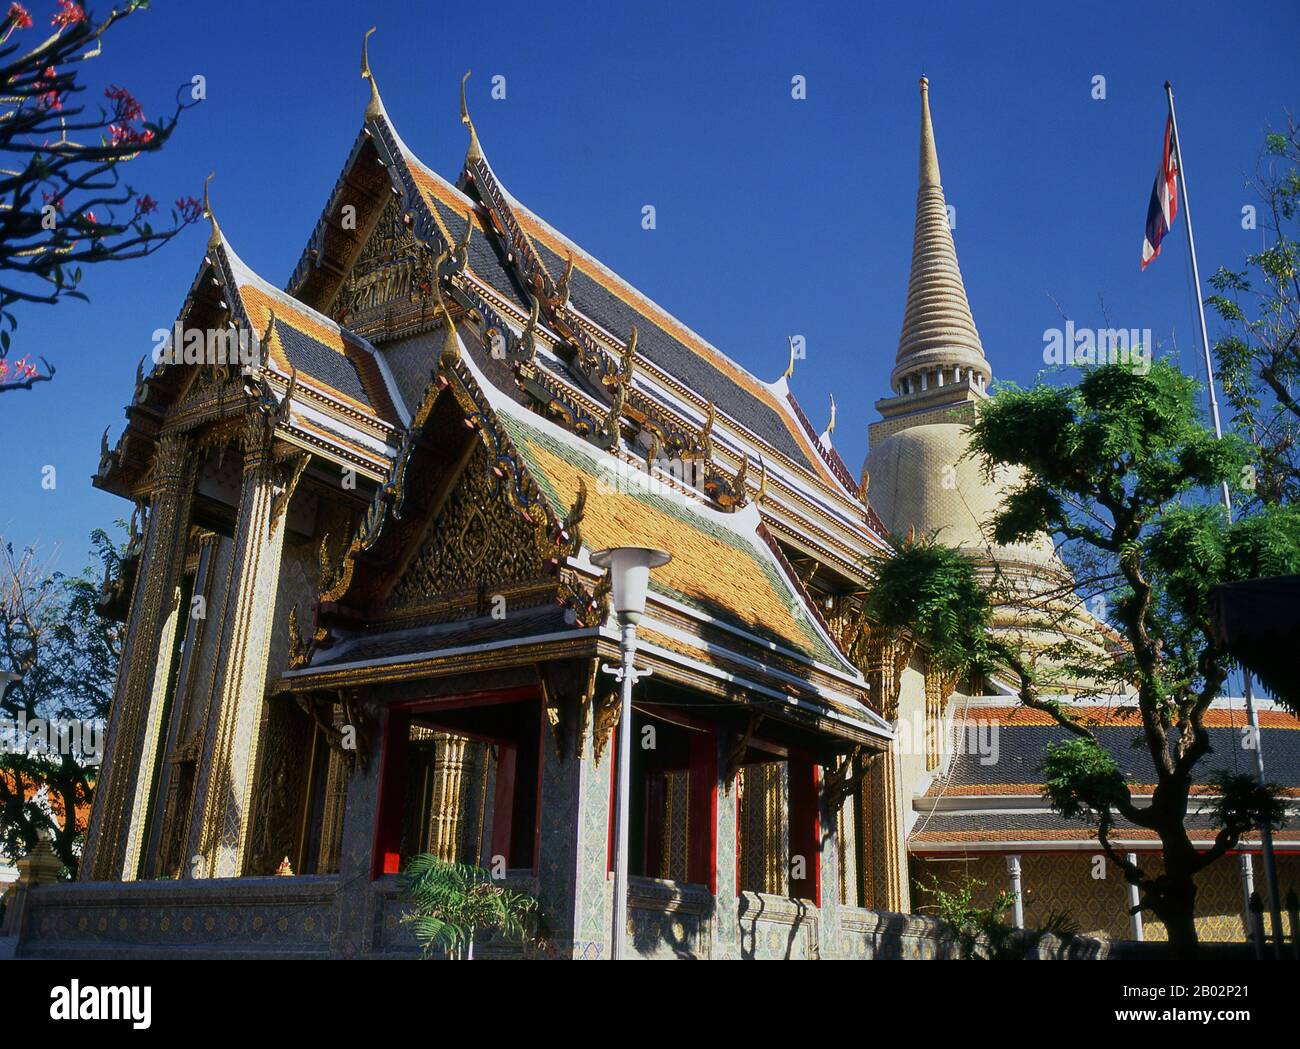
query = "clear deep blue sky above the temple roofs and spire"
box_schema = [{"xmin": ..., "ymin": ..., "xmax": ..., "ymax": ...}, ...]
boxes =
[{"xmin": 0, "ymin": 0, "xmax": 1300, "ymax": 571}]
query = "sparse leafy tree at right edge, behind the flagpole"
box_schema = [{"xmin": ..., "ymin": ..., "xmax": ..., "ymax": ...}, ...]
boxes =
[{"xmin": 1206, "ymin": 120, "xmax": 1300, "ymax": 503}]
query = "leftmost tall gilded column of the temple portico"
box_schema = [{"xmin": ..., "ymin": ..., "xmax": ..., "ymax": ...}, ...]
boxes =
[{"xmin": 82, "ymin": 433, "xmax": 195, "ymax": 881}]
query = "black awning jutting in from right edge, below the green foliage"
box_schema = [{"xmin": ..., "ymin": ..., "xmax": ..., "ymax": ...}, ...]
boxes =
[{"xmin": 1210, "ymin": 576, "xmax": 1300, "ymax": 715}]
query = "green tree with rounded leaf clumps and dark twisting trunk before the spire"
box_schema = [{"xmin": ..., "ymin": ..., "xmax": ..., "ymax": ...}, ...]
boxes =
[{"xmin": 867, "ymin": 361, "xmax": 1300, "ymax": 957}]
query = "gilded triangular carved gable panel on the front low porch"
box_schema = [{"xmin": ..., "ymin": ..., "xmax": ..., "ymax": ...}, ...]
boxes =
[{"xmin": 387, "ymin": 445, "xmax": 547, "ymax": 615}]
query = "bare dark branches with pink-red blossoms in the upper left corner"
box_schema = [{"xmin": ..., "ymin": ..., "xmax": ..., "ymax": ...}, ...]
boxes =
[{"xmin": 0, "ymin": 0, "xmax": 202, "ymax": 393}]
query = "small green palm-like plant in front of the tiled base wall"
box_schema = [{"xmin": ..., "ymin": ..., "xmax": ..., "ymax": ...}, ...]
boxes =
[{"xmin": 402, "ymin": 853, "xmax": 538, "ymax": 961}]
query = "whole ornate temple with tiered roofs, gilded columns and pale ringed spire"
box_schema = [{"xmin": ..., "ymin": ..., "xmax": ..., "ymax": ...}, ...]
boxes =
[{"xmin": 10, "ymin": 47, "xmax": 1300, "ymax": 958}]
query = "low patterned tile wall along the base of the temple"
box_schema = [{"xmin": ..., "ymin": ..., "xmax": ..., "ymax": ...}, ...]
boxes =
[{"xmin": 17, "ymin": 877, "xmax": 1258, "ymax": 959}]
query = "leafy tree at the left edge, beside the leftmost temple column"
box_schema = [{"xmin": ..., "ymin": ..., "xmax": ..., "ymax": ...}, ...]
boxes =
[{"xmin": 0, "ymin": 529, "xmax": 122, "ymax": 877}]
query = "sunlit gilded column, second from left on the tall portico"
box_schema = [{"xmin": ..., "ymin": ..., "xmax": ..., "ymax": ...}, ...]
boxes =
[{"xmin": 195, "ymin": 413, "xmax": 296, "ymax": 877}]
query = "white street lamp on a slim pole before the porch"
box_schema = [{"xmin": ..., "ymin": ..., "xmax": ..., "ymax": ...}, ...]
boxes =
[{"xmin": 592, "ymin": 546, "xmax": 672, "ymax": 961}]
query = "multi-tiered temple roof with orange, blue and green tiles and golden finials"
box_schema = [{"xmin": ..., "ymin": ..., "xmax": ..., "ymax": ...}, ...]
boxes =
[{"xmin": 98, "ymin": 36, "xmax": 888, "ymax": 746}]
